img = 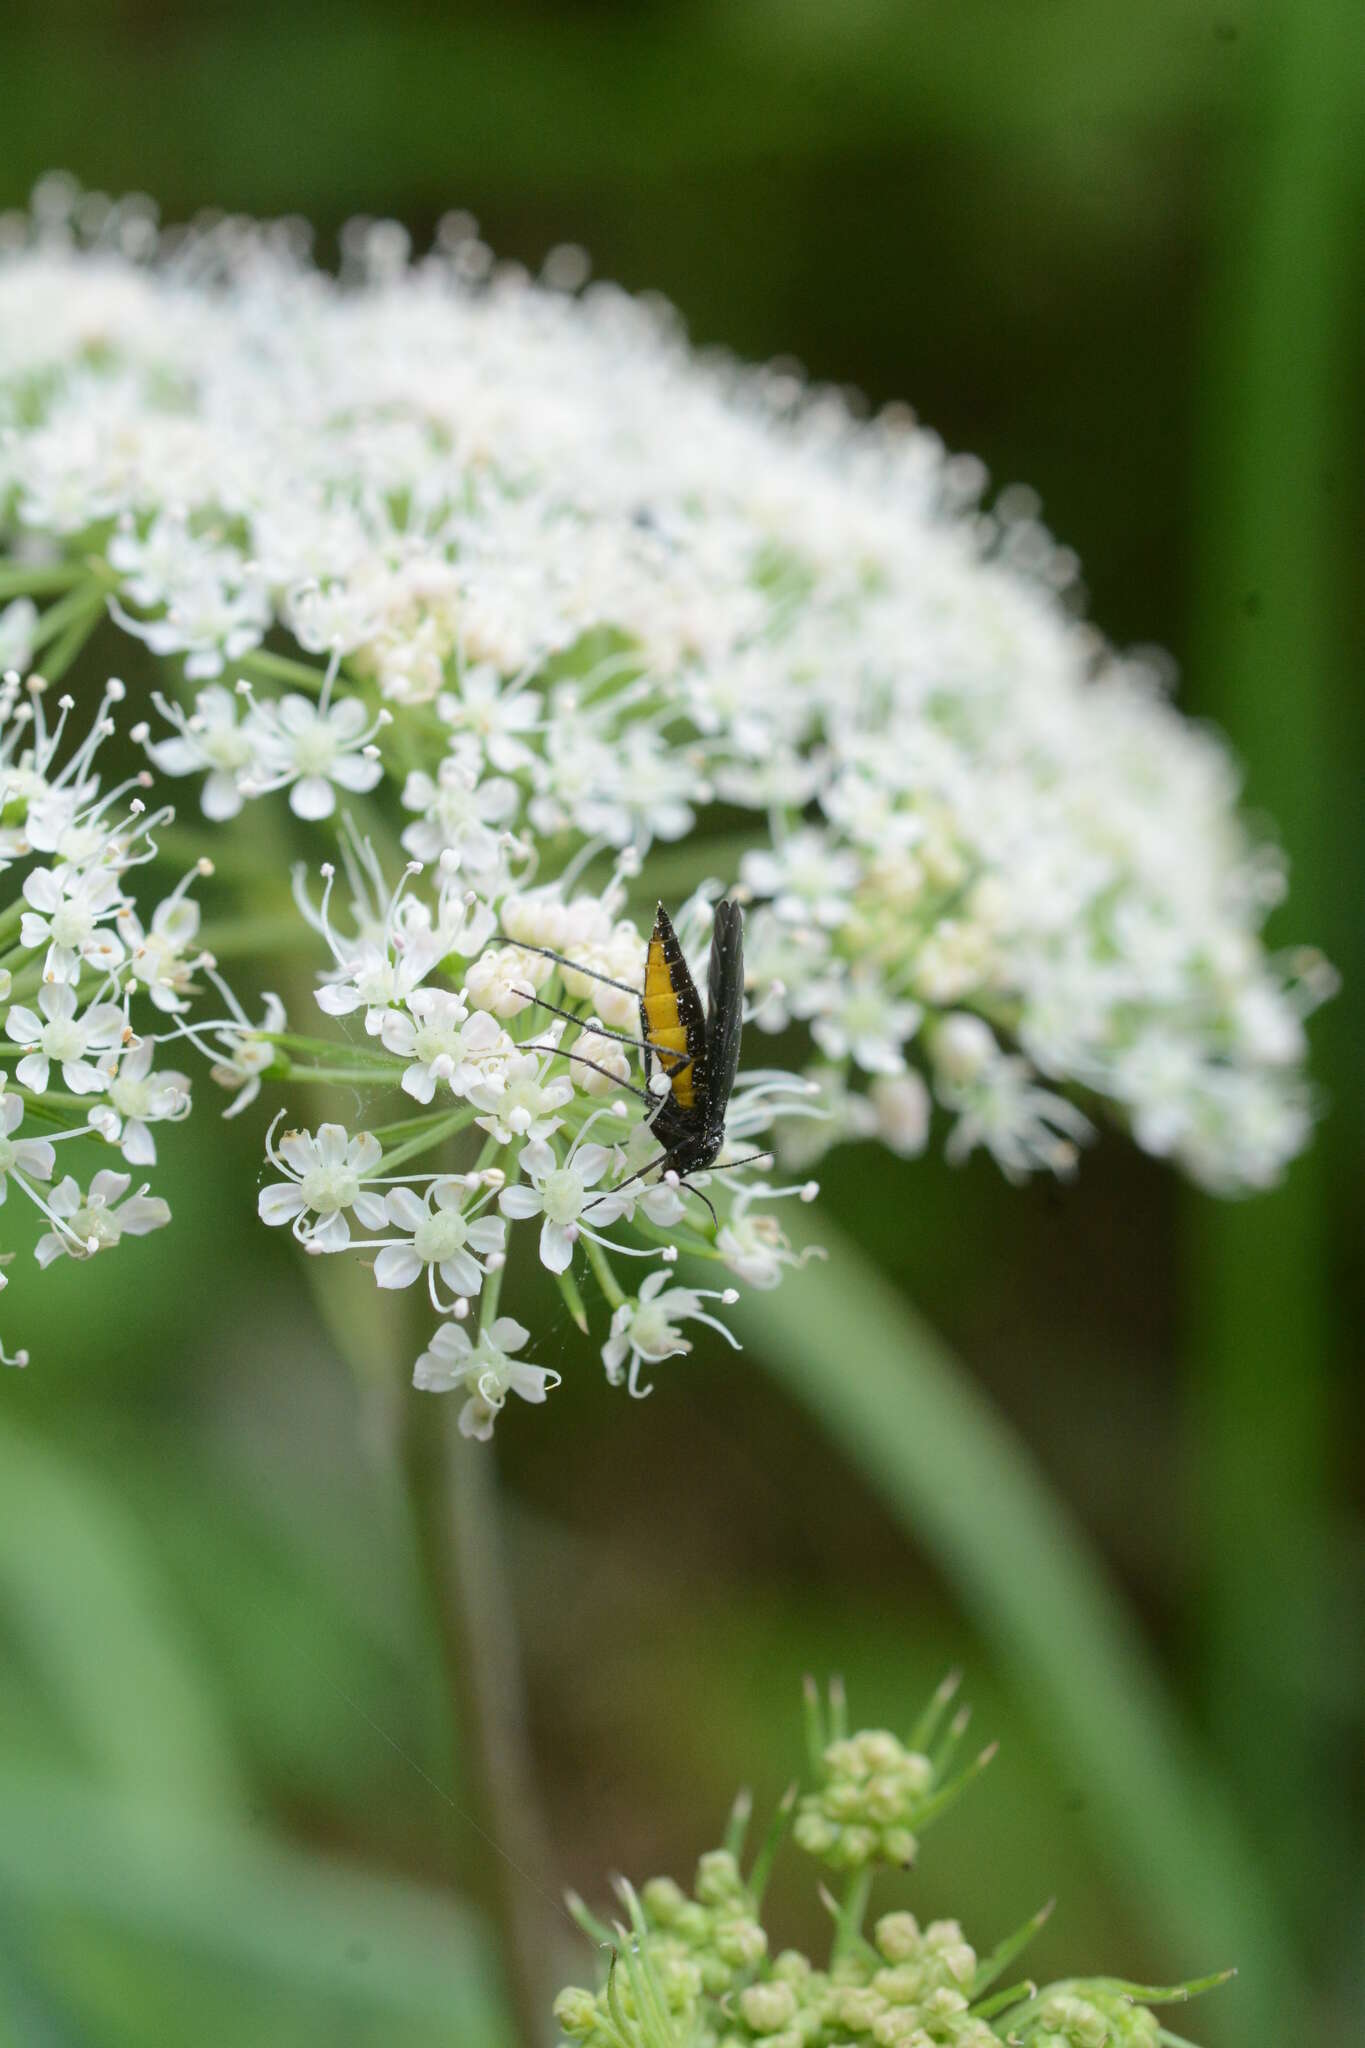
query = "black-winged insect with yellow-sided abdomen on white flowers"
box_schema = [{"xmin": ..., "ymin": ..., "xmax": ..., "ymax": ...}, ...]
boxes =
[{"xmin": 514, "ymin": 901, "xmax": 769, "ymax": 1217}]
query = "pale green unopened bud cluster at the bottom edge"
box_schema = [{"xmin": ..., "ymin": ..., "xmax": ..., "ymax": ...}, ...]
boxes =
[{"xmin": 555, "ymin": 1683, "xmax": 1222, "ymax": 2048}]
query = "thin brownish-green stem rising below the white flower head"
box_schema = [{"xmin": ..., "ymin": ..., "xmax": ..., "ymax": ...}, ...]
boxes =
[{"xmin": 403, "ymin": 1274, "xmax": 553, "ymax": 2048}]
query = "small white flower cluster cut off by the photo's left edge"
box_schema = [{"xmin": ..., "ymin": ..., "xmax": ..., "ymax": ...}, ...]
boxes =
[{"xmin": 0, "ymin": 670, "xmax": 248, "ymax": 1364}]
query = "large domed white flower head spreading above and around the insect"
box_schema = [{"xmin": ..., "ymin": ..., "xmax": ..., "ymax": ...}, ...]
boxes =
[{"xmin": 0, "ymin": 180, "xmax": 1332, "ymax": 1427}]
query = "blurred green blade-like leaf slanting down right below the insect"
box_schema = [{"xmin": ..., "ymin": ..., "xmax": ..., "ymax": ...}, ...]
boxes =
[{"xmin": 735, "ymin": 1219, "xmax": 1302, "ymax": 2048}]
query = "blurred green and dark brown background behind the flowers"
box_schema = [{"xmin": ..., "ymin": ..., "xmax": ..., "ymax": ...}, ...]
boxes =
[{"xmin": 0, "ymin": 12, "xmax": 1365, "ymax": 2048}]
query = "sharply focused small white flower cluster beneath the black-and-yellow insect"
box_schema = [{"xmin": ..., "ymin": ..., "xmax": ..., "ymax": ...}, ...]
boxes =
[{"xmin": 245, "ymin": 834, "xmax": 814, "ymax": 1438}]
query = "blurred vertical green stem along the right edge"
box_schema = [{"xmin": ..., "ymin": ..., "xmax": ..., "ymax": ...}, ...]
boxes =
[{"xmin": 1189, "ymin": 0, "xmax": 1365, "ymax": 1933}]
